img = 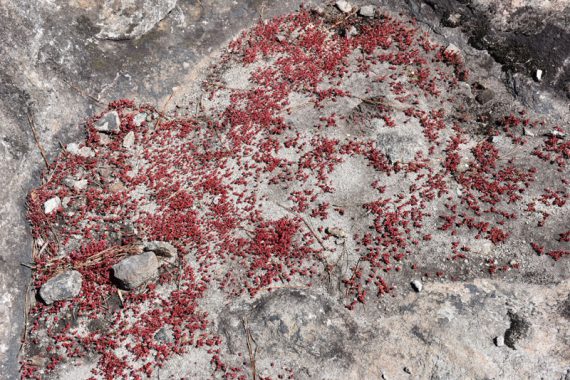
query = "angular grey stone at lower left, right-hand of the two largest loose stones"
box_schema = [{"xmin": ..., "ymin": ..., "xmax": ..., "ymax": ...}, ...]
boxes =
[{"xmin": 113, "ymin": 252, "xmax": 158, "ymax": 290}]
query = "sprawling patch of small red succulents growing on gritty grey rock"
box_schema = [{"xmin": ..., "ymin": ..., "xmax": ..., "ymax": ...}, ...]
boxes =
[{"xmin": 22, "ymin": 6, "xmax": 568, "ymax": 379}]
